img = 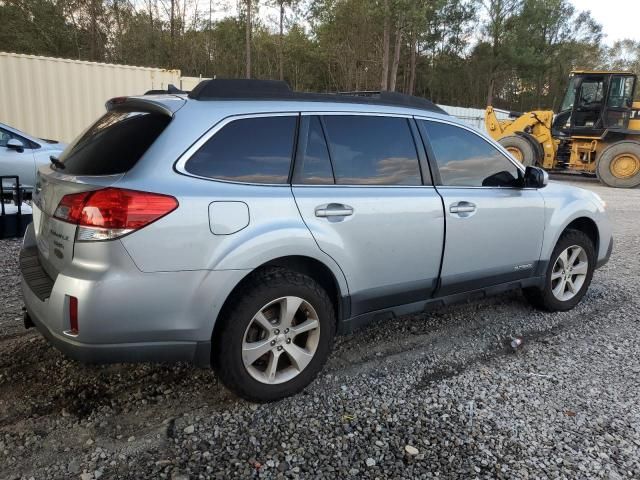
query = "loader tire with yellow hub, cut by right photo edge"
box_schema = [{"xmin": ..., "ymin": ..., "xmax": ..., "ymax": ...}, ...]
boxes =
[{"xmin": 596, "ymin": 140, "xmax": 640, "ymax": 188}]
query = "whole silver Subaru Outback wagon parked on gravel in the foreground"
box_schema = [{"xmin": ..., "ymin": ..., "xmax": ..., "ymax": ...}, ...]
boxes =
[{"xmin": 20, "ymin": 80, "xmax": 612, "ymax": 401}]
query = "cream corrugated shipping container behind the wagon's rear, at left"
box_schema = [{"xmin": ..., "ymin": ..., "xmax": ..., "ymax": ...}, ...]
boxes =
[{"xmin": 0, "ymin": 52, "xmax": 180, "ymax": 142}]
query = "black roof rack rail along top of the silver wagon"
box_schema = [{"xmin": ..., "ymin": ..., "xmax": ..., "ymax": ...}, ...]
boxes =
[{"xmin": 189, "ymin": 79, "xmax": 448, "ymax": 115}]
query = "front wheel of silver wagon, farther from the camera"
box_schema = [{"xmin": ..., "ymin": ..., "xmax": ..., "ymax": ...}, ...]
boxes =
[{"xmin": 524, "ymin": 230, "xmax": 596, "ymax": 312}]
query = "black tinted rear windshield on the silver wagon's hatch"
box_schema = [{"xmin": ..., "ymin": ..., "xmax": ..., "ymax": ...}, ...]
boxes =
[{"xmin": 59, "ymin": 110, "xmax": 171, "ymax": 175}]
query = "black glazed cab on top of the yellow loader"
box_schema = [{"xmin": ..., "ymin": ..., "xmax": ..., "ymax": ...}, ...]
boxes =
[{"xmin": 552, "ymin": 71, "xmax": 636, "ymax": 137}]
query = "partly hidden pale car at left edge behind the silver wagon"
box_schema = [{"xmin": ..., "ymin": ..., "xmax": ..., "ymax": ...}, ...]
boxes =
[{"xmin": 0, "ymin": 123, "xmax": 67, "ymax": 193}]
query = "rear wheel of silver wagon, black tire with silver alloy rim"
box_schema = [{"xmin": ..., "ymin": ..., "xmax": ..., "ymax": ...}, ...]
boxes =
[{"xmin": 212, "ymin": 268, "xmax": 336, "ymax": 402}]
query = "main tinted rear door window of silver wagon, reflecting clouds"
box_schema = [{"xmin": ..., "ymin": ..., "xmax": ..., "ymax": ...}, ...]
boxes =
[{"xmin": 323, "ymin": 115, "xmax": 422, "ymax": 185}]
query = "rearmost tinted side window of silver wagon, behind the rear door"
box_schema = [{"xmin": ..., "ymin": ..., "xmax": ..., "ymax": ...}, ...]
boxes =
[{"xmin": 185, "ymin": 116, "xmax": 297, "ymax": 184}]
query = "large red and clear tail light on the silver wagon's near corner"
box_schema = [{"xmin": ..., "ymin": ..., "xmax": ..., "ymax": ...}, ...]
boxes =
[{"xmin": 53, "ymin": 188, "xmax": 178, "ymax": 241}]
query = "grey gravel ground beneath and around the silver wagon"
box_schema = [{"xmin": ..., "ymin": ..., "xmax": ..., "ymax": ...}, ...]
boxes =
[{"xmin": 0, "ymin": 180, "xmax": 640, "ymax": 480}]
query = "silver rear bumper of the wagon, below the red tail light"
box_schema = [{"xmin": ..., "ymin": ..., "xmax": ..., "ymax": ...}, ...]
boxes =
[{"xmin": 21, "ymin": 225, "xmax": 249, "ymax": 366}]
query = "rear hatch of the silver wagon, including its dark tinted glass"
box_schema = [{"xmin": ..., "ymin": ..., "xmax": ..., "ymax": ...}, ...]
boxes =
[{"xmin": 33, "ymin": 97, "xmax": 184, "ymax": 279}]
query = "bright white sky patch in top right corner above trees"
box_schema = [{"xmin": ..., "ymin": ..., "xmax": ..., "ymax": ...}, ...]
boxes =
[{"xmin": 571, "ymin": 0, "xmax": 640, "ymax": 45}]
